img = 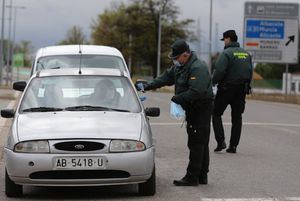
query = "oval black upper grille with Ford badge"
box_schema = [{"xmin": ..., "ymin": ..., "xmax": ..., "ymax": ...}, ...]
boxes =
[{"xmin": 54, "ymin": 141, "xmax": 105, "ymax": 151}]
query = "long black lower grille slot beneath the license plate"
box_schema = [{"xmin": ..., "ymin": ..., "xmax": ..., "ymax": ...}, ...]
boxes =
[{"xmin": 29, "ymin": 170, "xmax": 130, "ymax": 179}]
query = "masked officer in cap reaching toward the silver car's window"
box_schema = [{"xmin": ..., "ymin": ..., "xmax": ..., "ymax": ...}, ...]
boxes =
[{"xmin": 136, "ymin": 39, "xmax": 213, "ymax": 186}]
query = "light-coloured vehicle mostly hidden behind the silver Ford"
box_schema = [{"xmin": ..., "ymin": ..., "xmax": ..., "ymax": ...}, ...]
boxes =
[{"xmin": 31, "ymin": 44, "xmax": 130, "ymax": 76}]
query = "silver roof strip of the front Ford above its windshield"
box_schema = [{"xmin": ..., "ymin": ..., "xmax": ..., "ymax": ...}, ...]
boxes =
[{"xmin": 33, "ymin": 68, "xmax": 128, "ymax": 77}]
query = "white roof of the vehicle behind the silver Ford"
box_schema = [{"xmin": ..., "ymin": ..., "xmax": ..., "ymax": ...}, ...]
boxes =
[{"xmin": 36, "ymin": 45, "xmax": 123, "ymax": 58}]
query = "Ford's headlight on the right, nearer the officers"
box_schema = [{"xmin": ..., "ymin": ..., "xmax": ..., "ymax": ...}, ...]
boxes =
[{"xmin": 109, "ymin": 140, "xmax": 146, "ymax": 152}]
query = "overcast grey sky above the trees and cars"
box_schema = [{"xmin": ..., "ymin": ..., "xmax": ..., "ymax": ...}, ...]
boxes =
[{"xmin": 1, "ymin": 0, "xmax": 300, "ymax": 56}]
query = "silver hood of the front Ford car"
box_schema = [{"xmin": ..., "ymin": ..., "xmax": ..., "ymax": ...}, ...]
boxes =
[{"xmin": 17, "ymin": 111, "xmax": 142, "ymax": 141}]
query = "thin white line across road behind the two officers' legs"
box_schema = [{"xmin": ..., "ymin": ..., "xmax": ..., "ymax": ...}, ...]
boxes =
[{"xmin": 150, "ymin": 122, "xmax": 300, "ymax": 127}]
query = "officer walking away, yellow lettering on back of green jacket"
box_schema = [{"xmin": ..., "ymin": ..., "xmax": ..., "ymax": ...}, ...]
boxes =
[{"xmin": 212, "ymin": 30, "xmax": 252, "ymax": 153}]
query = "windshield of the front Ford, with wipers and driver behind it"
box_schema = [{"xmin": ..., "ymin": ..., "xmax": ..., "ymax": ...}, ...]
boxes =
[{"xmin": 19, "ymin": 75, "xmax": 141, "ymax": 113}]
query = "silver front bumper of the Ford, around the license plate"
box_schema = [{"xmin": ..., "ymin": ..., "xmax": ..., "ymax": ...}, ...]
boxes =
[{"xmin": 4, "ymin": 147, "xmax": 154, "ymax": 186}]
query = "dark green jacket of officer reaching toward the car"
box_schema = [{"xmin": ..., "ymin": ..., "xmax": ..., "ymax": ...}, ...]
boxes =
[{"xmin": 148, "ymin": 53, "xmax": 213, "ymax": 112}]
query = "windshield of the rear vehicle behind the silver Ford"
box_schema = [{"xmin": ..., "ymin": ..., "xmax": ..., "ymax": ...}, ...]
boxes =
[{"xmin": 36, "ymin": 55, "xmax": 126, "ymax": 71}]
